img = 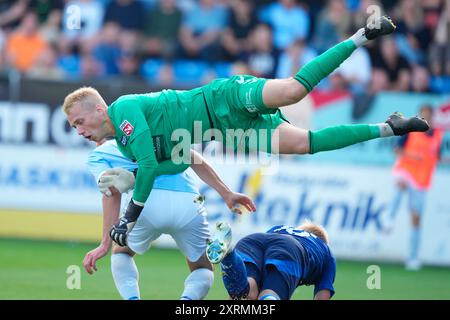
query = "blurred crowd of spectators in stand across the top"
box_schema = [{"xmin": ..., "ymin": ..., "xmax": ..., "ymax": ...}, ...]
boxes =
[{"xmin": 0, "ymin": 0, "xmax": 450, "ymax": 96}]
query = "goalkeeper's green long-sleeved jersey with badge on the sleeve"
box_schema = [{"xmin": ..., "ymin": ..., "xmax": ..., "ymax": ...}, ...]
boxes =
[{"xmin": 108, "ymin": 89, "xmax": 209, "ymax": 203}]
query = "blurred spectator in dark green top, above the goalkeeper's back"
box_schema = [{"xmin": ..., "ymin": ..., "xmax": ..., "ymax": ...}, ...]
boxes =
[{"xmin": 144, "ymin": 0, "xmax": 182, "ymax": 59}]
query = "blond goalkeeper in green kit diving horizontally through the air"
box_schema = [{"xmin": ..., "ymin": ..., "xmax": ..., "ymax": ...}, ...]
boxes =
[{"xmin": 63, "ymin": 16, "xmax": 429, "ymax": 246}]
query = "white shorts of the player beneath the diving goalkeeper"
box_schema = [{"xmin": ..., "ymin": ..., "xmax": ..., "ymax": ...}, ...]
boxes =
[{"xmin": 128, "ymin": 189, "xmax": 210, "ymax": 262}]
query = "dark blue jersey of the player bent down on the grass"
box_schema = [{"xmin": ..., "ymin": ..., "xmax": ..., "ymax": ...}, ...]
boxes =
[{"xmin": 267, "ymin": 225, "xmax": 336, "ymax": 295}]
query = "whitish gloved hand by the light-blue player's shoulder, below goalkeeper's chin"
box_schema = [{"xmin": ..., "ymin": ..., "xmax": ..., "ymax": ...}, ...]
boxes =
[{"xmin": 98, "ymin": 168, "xmax": 136, "ymax": 197}]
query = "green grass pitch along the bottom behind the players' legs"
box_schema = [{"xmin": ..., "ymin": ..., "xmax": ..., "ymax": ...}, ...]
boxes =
[{"xmin": 0, "ymin": 239, "xmax": 450, "ymax": 300}]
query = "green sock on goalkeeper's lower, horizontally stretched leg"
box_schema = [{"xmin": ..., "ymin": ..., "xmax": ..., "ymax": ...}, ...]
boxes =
[{"xmin": 309, "ymin": 124, "xmax": 381, "ymax": 154}]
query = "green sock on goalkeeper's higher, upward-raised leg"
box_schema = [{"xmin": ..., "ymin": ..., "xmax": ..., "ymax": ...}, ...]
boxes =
[{"xmin": 294, "ymin": 40, "xmax": 356, "ymax": 92}]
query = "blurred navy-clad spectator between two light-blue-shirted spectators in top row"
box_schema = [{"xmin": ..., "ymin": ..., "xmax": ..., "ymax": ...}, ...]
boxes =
[{"xmin": 222, "ymin": 0, "xmax": 257, "ymax": 61}]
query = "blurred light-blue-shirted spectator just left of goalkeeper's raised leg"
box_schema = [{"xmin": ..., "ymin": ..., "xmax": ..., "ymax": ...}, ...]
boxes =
[{"xmin": 260, "ymin": 0, "xmax": 310, "ymax": 50}]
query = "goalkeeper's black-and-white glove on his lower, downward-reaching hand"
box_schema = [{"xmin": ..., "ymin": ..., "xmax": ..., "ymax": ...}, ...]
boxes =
[{"xmin": 109, "ymin": 199, "xmax": 144, "ymax": 247}]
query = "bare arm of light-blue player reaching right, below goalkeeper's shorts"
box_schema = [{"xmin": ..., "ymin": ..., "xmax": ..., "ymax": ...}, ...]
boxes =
[{"xmin": 191, "ymin": 150, "xmax": 256, "ymax": 214}]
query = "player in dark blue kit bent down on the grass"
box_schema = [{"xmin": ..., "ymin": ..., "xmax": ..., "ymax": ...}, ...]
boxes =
[{"xmin": 206, "ymin": 222, "xmax": 336, "ymax": 300}]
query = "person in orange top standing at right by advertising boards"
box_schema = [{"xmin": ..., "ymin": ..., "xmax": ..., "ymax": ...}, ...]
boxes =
[{"xmin": 385, "ymin": 105, "xmax": 443, "ymax": 270}]
